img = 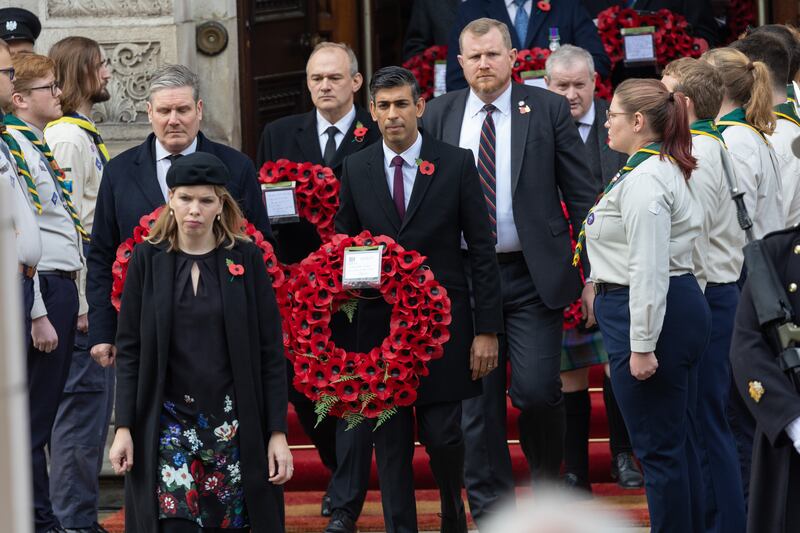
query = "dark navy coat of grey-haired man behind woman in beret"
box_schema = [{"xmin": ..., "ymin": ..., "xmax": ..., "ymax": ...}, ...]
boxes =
[{"xmin": 86, "ymin": 133, "xmax": 275, "ymax": 346}]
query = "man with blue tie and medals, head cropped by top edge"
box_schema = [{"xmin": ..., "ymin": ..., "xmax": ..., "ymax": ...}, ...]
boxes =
[{"xmin": 447, "ymin": 0, "xmax": 611, "ymax": 91}]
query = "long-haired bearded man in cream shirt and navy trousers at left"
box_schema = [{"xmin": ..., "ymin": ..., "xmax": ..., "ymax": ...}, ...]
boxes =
[{"xmin": 44, "ymin": 37, "xmax": 114, "ymax": 533}]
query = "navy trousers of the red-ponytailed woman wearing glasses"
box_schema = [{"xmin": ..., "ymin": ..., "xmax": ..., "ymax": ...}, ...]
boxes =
[{"xmin": 594, "ymin": 276, "xmax": 711, "ymax": 533}]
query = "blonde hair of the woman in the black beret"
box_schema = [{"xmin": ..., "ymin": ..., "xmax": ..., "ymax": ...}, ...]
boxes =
[{"xmin": 145, "ymin": 185, "xmax": 249, "ymax": 252}]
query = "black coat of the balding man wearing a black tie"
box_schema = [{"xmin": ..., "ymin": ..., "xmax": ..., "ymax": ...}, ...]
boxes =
[{"xmin": 256, "ymin": 106, "xmax": 381, "ymax": 264}]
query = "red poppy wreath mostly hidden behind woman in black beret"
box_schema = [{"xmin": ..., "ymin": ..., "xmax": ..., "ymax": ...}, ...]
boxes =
[{"xmin": 111, "ymin": 206, "xmax": 288, "ymax": 316}]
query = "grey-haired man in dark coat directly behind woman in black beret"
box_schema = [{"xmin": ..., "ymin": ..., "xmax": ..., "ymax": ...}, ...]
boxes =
[{"xmin": 86, "ymin": 65, "xmax": 274, "ymax": 382}]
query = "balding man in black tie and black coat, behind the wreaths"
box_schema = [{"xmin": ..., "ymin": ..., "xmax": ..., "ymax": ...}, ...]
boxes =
[{"xmin": 258, "ymin": 42, "xmax": 381, "ymax": 526}]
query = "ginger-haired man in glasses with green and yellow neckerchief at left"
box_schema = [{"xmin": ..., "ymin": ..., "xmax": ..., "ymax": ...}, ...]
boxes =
[{"xmin": 3, "ymin": 53, "xmax": 86, "ymax": 533}]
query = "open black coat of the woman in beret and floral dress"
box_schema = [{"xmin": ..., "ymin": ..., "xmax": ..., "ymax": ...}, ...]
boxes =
[{"xmin": 115, "ymin": 242, "xmax": 287, "ymax": 533}]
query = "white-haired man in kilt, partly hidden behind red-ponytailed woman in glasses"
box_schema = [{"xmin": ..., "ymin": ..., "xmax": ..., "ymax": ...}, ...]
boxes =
[{"xmin": 545, "ymin": 44, "xmax": 643, "ymax": 490}]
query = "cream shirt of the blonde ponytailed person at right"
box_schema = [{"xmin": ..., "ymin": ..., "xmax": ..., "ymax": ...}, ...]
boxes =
[{"xmin": 722, "ymin": 126, "xmax": 786, "ymax": 239}]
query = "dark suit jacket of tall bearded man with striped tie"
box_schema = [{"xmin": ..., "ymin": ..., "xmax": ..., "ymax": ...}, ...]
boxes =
[{"xmin": 422, "ymin": 84, "xmax": 597, "ymax": 309}]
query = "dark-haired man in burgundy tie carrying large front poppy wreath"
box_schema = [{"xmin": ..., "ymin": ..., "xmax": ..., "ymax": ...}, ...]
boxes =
[{"xmin": 336, "ymin": 67, "xmax": 502, "ymax": 533}]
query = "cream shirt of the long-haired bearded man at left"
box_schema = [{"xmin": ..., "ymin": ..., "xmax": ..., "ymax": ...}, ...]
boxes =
[{"xmin": 44, "ymin": 122, "xmax": 103, "ymax": 315}]
